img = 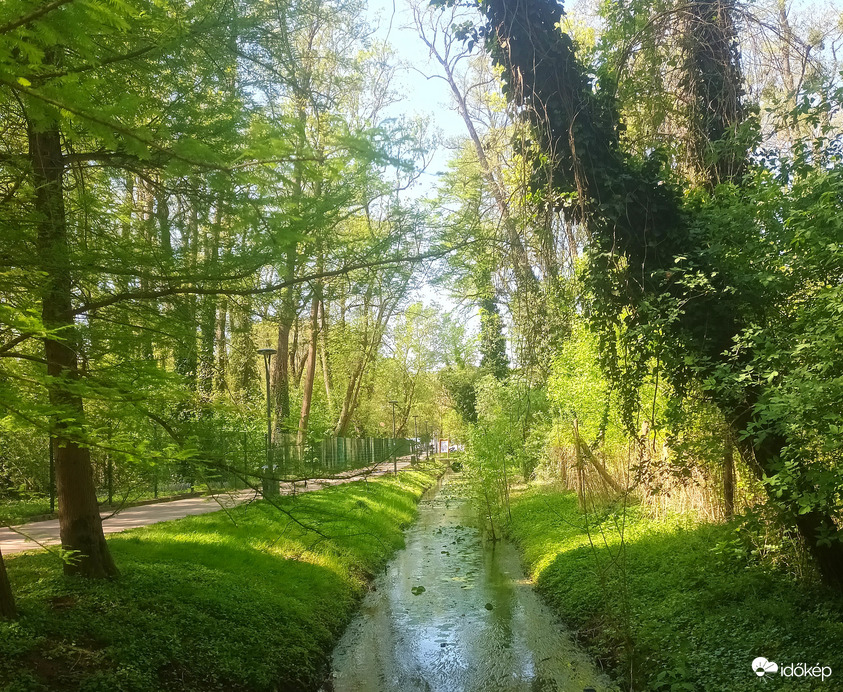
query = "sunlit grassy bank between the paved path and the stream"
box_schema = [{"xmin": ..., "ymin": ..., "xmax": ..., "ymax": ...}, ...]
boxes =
[{"xmin": 0, "ymin": 460, "xmax": 446, "ymax": 692}]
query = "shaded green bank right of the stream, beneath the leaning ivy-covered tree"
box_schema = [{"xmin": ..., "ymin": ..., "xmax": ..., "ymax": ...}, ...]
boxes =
[{"xmin": 512, "ymin": 488, "xmax": 843, "ymax": 692}]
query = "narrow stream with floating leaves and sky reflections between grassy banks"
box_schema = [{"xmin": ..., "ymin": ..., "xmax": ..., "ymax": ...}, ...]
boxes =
[{"xmin": 323, "ymin": 477, "xmax": 615, "ymax": 692}]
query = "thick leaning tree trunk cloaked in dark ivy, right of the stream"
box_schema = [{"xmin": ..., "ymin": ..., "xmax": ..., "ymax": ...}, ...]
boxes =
[{"xmin": 462, "ymin": 0, "xmax": 843, "ymax": 589}]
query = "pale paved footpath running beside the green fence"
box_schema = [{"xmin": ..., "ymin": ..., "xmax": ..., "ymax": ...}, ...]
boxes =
[{"xmin": 0, "ymin": 459, "xmax": 410, "ymax": 556}]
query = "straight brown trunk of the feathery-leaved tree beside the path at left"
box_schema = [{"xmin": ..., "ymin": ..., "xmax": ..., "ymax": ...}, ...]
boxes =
[{"xmin": 28, "ymin": 123, "xmax": 117, "ymax": 577}]
